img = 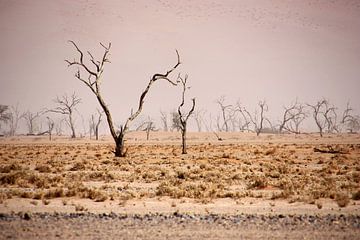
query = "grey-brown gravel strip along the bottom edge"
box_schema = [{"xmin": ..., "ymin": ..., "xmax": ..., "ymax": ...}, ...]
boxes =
[{"xmin": 0, "ymin": 212, "xmax": 360, "ymax": 240}]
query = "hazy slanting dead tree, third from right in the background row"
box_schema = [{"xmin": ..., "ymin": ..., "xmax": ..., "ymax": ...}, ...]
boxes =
[{"xmin": 279, "ymin": 100, "xmax": 307, "ymax": 134}]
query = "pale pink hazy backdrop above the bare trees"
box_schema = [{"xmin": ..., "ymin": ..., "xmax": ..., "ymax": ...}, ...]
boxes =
[{"xmin": 0, "ymin": 0, "xmax": 360, "ymax": 131}]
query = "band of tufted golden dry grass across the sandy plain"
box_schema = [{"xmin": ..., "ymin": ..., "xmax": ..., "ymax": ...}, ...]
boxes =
[{"xmin": 0, "ymin": 136, "xmax": 360, "ymax": 207}]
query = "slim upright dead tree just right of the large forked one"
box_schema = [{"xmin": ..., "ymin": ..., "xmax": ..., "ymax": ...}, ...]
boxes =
[{"xmin": 178, "ymin": 74, "xmax": 195, "ymax": 154}]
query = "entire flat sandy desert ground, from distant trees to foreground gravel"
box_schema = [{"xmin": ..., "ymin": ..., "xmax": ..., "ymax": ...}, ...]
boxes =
[{"xmin": 0, "ymin": 132, "xmax": 360, "ymax": 239}]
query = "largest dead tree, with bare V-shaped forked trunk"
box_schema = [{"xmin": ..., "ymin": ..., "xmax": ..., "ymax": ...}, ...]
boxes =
[{"xmin": 65, "ymin": 41, "xmax": 180, "ymax": 157}]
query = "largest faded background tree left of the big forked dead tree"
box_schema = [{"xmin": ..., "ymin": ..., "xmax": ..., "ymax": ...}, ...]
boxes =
[{"xmin": 49, "ymin": 93, "xmax": 81, "ymax": 138}]
